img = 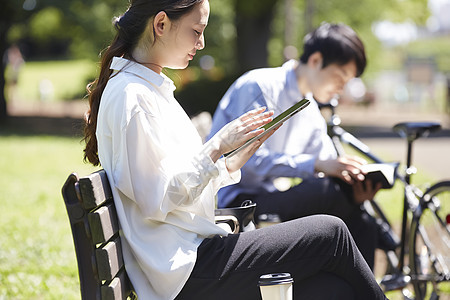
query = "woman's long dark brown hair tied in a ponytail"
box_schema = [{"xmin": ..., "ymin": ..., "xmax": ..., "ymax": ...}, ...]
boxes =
[{"xmin": 84, "ymin": 0, "xmax": 204, "ymax": 166}]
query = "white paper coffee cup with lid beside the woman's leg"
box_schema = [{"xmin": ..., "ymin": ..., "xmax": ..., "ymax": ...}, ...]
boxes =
[{"xmin": 258, "ymin": 273, "xmax": 294, "ymax": 300}]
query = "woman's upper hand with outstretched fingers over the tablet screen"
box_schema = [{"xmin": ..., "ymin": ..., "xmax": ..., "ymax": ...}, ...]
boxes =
[{"xmin": 208, "ymin": 107, "xmax": 273, "ymax": 161}]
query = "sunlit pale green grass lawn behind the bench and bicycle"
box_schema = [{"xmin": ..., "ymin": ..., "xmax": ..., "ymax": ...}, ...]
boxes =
[{"xmin": 0, "ymin": 61, "xmax": 446, "ymax": 300}]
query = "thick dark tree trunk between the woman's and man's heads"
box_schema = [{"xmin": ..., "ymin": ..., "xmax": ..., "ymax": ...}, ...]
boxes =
[{"xmin": 235, "ymin": 0, "xmax": 277, "ymax": 74}]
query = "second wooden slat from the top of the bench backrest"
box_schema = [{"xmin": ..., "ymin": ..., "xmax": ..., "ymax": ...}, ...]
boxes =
[{"xmin": 88, "ymin": 201, "xmax": 119, "ymax": 244}]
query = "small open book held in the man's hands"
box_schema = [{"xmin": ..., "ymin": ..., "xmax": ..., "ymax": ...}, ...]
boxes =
[{"xmin": 361, "ymin": 163, "xmax": 399, "ymax": 189}]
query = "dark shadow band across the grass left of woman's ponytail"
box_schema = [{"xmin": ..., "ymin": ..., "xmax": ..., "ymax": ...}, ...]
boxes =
[{"xmin": 0, "ymin": 116, "xmax": 84, "ymax": 138}]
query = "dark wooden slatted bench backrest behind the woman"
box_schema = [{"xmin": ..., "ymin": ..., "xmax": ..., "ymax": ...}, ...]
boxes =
[{"xmin": 62, "ymin": 170, "xmax": 135, "ymax": 300}]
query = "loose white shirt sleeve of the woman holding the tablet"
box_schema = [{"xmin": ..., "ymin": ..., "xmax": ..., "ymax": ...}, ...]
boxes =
[{"xmin": 110, "ymin": 112, "xmax": 230, "ymax": 220}]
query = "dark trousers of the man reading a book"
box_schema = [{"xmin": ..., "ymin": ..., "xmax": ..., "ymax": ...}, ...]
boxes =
[{"xmin": 229, "ymin": 177, "xmax": 378, "ymax": 270}]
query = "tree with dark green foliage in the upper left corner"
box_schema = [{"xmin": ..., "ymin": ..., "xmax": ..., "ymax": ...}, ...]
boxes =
[{"xmin": 0, "ymin": 0, "xmax": 128, "ymax": 121}]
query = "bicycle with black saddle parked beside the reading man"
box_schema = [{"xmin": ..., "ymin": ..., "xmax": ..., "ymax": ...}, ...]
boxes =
[{"xmin": 319, "ymin": 99, "xmax": 450, "ymax": 300}]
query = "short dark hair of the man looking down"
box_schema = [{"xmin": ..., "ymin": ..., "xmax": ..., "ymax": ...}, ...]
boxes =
[{"xmin": 300, "ymin": 23, "xmax": 367, "ymax": 77}]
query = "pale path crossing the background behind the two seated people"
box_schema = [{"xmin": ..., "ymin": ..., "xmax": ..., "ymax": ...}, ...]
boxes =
[{"xmin": 8, "ymin": 99, "xmax": 450, "ymax": 179}]
